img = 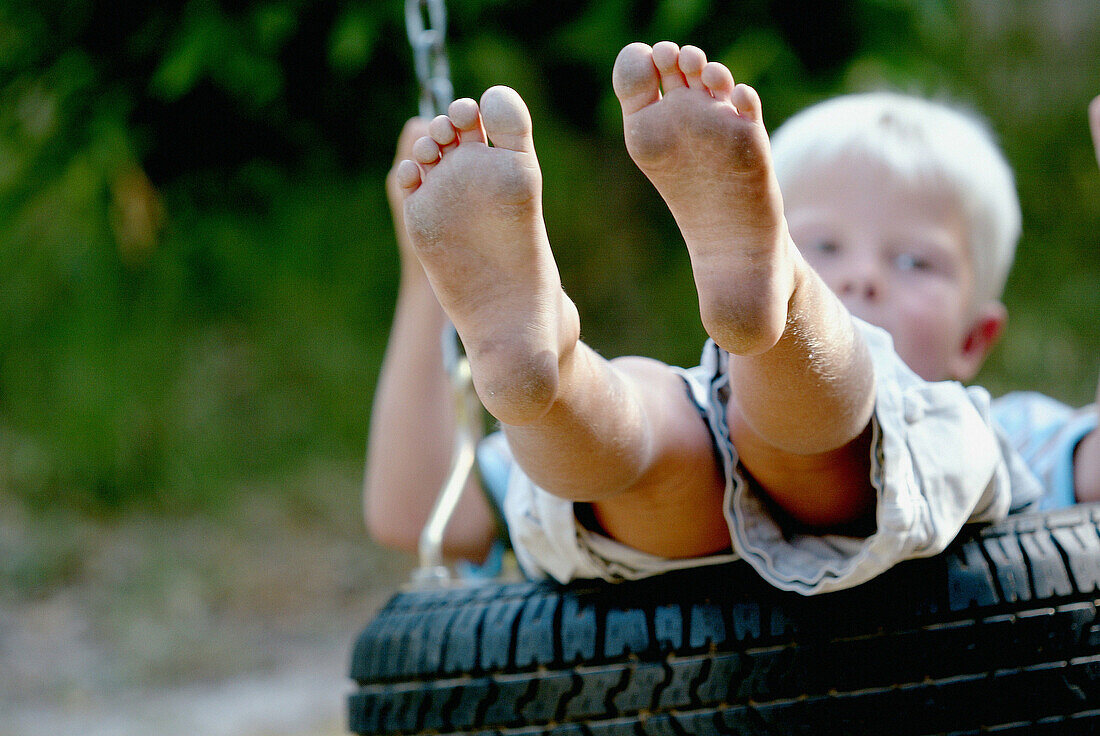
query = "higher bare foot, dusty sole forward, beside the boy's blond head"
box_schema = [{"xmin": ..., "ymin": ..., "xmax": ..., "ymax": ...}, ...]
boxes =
[{"xmin": 613, "ymin": 41, "xmax": 794, "ymax": 355}]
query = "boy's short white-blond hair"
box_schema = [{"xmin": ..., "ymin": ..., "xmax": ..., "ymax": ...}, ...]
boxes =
[{"xmin": 771, "ymin": 92, "xmax": 1021, "ymax": 304}]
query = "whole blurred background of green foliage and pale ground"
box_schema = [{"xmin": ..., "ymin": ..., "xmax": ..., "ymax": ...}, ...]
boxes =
[{"xmin": 0, "ymin": 0, "xmax": 1100, "ymax": 734}]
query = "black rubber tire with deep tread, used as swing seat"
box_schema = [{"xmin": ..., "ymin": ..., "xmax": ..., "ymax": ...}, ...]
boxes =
[{"xmin": 349, "ymin": 506, "xmax": 1100, "ymax": 736}]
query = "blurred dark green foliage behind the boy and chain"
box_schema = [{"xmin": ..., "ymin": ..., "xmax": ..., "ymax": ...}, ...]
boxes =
[{"xmin": 0, "ymin": 0, "xmax": 1100, "ymax": 513}]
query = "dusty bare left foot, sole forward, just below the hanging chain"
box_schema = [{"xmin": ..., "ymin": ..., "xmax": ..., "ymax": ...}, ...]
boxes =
[{"xmin": 396, "ymin": 87, "xmax": 580, "ymax": 425}]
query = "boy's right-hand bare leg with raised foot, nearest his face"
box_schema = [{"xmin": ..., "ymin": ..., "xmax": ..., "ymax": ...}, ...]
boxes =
[{"xmin": 614, "ymin": 42, "xmax": 873, "ymax": 525}]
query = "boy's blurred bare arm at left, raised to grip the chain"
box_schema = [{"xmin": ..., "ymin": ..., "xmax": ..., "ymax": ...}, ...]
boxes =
[{"xmin": 363, "ymin": 119, "xmax": 496, "ymax": 560}]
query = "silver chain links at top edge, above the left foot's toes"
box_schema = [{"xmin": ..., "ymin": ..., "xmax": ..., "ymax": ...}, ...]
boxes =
[{"xmin": 405, "ymin": 0, "xmax": 454, "ymax": 120}]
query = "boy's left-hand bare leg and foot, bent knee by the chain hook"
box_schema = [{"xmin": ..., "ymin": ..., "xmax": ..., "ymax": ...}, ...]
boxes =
[{"xmin": 398, "ymin": 87, "xmax": 729, "ymax": 556}]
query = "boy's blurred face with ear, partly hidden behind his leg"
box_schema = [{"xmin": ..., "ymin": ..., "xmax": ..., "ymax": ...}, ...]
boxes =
[{"xmin": 783, "ymin": 162, "xmax": 1003, "ymax": 381}]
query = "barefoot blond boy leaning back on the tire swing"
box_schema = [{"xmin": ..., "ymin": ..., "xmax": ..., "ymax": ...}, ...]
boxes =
[{"xmin": 366, "ymin": 42, "xmax": 1097, "ymax": 593}]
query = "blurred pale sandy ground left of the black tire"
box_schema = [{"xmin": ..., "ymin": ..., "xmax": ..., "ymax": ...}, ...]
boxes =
[{"xmin": 0, "ymin": 481, "xmax": 410, "ymax": 736}]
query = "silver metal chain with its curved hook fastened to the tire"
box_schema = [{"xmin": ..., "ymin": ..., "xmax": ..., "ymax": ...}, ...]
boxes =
[{"xmin": 405, "ymin": 0, "xmax": 482, "ymax": 589}]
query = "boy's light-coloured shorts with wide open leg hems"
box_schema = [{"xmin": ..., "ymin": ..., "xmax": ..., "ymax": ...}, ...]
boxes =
[{"xmin": 504, "ymin": 320, "xmax": 1041, "ymax": 595}]
